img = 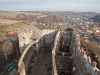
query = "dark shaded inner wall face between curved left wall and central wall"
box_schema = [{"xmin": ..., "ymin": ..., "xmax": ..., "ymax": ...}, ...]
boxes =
[{"xmin": 38, "ymin": 32, "xmax": 57, "ymax": 53}]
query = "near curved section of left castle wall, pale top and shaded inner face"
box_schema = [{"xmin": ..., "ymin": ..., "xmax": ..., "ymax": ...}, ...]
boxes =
[{"xmin": 18, "ymin": 43, "xmax": 36, "ymax": 75}]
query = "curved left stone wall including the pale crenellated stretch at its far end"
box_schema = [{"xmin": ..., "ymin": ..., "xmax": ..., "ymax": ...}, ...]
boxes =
[{"xmin": 18, "ymin": 29, "xmax": 57, "ymax": 75}]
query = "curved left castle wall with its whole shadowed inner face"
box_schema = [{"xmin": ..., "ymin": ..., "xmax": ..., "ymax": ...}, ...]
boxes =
[{"xmin": 18, "ymin": 31, "xmax": 57, "ymax": 75}]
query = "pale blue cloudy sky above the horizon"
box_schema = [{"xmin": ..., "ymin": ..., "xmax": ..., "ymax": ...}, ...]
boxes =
[{"xmin": 0, "ymin": 0, "xmax": 100, "ymax": 13}]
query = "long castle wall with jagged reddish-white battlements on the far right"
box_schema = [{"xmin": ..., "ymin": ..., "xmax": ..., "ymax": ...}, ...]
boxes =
[{"xmin": 73, "ymin": 33, "xmax": 100, "ymax": 75}]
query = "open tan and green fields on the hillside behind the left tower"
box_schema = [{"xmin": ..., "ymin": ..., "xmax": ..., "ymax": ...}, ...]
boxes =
[{"xmin": 0, "ymin": 11, "xmax": 48, "ymax": 41}]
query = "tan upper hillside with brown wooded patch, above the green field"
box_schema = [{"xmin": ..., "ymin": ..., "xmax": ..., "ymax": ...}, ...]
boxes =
[{"xmin": 0, "ymin": 11, "xmax": 48, "ymax": 24}]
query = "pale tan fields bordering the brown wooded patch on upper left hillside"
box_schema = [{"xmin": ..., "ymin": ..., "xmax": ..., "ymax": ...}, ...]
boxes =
[{"xmin": 0, "ymin": 11, "xmax": 48, "ymax": 25}]
